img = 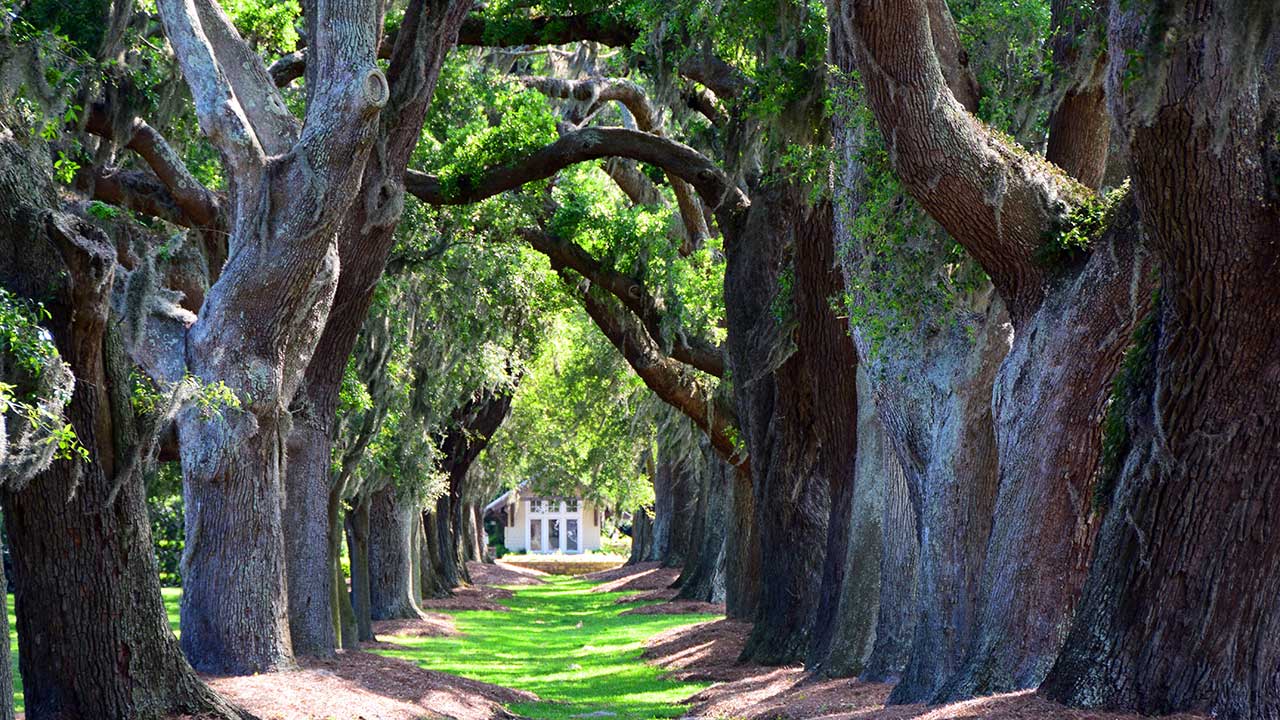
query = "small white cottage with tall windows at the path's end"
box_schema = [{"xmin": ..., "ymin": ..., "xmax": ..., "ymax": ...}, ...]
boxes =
[{"xmin": 484, "ymin": 487, "xmax": 604, "ymax": 553}]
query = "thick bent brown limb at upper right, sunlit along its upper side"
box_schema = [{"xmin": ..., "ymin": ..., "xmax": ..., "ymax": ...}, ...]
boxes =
[{"xmin": 832, "ymin": 0, "xmax": 1089, "ymax": 323}]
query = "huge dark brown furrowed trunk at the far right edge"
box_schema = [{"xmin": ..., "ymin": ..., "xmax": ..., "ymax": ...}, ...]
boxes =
[{"xmin": 1043, "ymin": 7, "xmax": 1280, "ymax": 719}]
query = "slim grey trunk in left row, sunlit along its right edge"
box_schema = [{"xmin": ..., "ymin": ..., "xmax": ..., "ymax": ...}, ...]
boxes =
[{"xmin": 369, "ymin": 486, "xmax": 422, "ymax": 620}]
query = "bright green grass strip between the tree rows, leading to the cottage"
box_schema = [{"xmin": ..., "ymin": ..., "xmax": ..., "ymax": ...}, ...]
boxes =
[{"xmin": 378, "ymin": 578, "xmax": 713, "ymax": 720}]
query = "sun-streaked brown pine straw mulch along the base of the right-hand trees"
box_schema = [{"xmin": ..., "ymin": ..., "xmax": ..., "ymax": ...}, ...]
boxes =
[{"xmin": 644, "ymin": 620, "xmax": 1203, "ymax": 720}]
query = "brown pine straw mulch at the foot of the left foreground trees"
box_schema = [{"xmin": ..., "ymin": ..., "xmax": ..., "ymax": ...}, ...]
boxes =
[{"xmin": 195, "ymin": 651, "xmax": 536, "ymax": 720}]
